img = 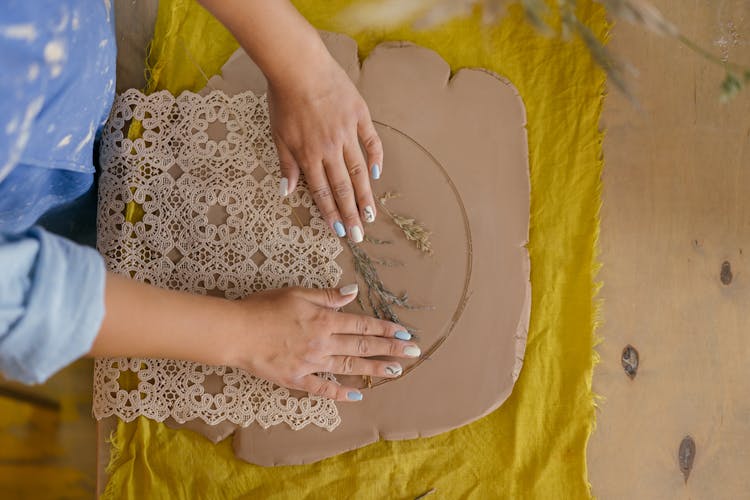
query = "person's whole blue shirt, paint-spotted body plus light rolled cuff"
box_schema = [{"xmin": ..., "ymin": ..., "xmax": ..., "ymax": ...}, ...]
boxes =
[{"xmin": 0, "ymin": 0, "xmax": 116, "ymax": 382}]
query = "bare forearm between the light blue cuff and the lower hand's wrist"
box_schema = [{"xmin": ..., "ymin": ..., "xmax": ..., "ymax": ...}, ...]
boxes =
[{"xmin": 89, "ymin": 273, "xmax": 242, "ymax": 364}]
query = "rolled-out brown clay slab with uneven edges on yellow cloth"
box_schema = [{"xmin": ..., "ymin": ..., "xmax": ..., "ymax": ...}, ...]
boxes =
[{"xmin": 170, "ymin": 33, "xmax": 531, "ymax": 465}]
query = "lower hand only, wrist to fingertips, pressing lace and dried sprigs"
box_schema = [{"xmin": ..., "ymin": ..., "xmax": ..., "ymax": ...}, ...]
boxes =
[{"xmin": 231, "ymin": 285, "xmax": 421, "ymax": 401}]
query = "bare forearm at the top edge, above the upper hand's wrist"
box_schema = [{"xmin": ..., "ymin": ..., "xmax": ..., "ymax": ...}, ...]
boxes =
[{"xmin": 198, "ymin": 0, "xmax": 329, "ymax": 85}]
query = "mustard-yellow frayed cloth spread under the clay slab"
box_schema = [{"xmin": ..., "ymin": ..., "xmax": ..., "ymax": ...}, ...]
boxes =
[{"xmin": 106, "ymin": 0, "xmax": 608, "ymax": 499}]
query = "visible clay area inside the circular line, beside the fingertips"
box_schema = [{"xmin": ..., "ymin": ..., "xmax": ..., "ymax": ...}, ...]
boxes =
[{"xmin": 338, "ymin": 123, "xmax": 472, "ymax": 389}]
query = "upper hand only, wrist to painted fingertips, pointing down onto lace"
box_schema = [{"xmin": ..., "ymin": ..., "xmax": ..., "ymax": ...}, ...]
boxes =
[{"xmin": 268, "ymin": 52, "xmax": 383, "ymax": 243}]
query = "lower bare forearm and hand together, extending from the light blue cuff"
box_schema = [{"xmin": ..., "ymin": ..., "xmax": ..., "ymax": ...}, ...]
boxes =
[{"xmin": 89, "ymin": 273, "xmax": 421, "ymax": 401}]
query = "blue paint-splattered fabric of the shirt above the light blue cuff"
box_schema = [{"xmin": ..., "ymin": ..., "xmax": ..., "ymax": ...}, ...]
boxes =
[{"xmin": 0, "ymin": 0, "xmax": 116, "ymax": 234}]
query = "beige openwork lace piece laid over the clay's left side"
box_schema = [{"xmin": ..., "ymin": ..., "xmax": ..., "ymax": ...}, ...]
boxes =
[{"xmin": 94, "ymin": 90, "xmax": 342, "ymax": 430}]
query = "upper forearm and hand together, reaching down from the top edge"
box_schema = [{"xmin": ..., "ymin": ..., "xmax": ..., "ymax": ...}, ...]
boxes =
[{"xmin": 199, "ymin": 0, "xmax": 383, "ymax": 243}]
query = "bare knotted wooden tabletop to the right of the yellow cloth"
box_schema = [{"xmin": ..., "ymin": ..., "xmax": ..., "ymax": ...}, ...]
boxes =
[{"xmin": 588, "ymin": 0, "xmax": 750, "ymax": 499}]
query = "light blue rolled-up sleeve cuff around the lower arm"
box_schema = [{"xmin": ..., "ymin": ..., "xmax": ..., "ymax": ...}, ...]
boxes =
[{"xmin": 0, "ymin": 227, "xmax": 106, "ymax": 383}]
